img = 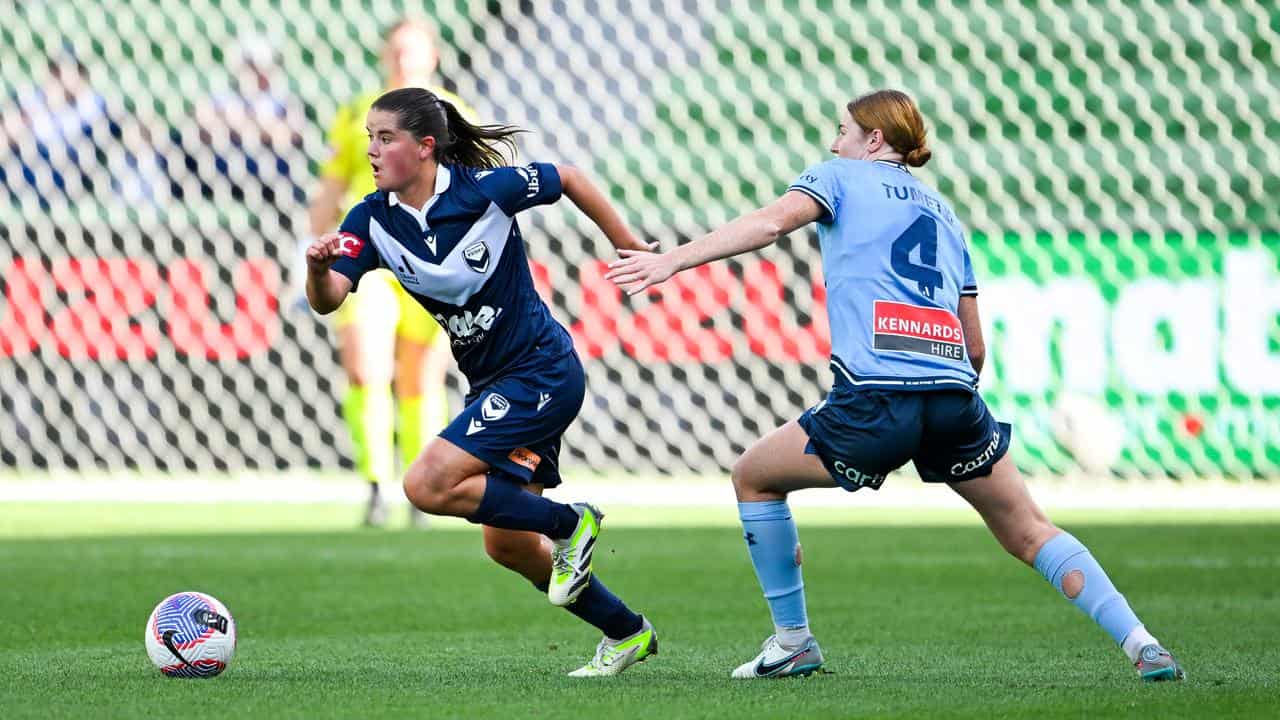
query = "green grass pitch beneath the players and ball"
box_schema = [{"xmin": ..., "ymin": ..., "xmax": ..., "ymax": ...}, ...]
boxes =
[{"xmin": 0, "ymin": 503, "xmax": 1280, "ymax": 720}]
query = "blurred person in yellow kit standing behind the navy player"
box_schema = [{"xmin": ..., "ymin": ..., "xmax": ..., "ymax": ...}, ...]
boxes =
[{"xmin": 308, "ymin": 18, "xmax": 475, "ymax": 525}]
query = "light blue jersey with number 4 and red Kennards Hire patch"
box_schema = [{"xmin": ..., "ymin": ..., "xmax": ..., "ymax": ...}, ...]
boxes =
[{"xmin": 791, "ymin": 159, "xmax": 978, "ymax": 389}]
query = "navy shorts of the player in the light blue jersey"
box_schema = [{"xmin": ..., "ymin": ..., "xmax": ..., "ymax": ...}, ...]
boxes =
[{"xmin": 797, "ymin": 382, "xmax": 1012, "ymax": 492}]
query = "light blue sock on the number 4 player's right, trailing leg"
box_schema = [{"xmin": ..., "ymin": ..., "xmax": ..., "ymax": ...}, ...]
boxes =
[{"xmin": 1036, "ymin": 532, "xmax": 1142, "ymax": 644}]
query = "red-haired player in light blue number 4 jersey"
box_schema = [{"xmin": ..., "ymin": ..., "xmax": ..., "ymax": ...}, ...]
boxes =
[{"xmin": 608, "ymin": 90, "xmax": 1184, "ymax": 680}]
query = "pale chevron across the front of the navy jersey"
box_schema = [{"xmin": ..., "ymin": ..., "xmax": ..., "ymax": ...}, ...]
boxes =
[{"xmin": 369, "ymin": 202, "xmax": 516, "ymax": 305}]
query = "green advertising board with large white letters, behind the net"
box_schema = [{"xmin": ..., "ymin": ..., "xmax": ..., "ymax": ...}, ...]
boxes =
[{"xmin": 972, "ymin": 233, "xmax": 1280, "ymax": 478}]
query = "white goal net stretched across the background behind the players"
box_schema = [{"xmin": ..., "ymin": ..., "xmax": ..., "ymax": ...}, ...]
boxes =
[{"xmin": 0, "ymin": 0, "xmax": 1280, "ymax": 478}]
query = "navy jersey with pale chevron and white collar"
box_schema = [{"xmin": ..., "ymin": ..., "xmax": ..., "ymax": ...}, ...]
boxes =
[{"xmin": 333, "ymin": 163, "xmax": 573, "ymax": 388}]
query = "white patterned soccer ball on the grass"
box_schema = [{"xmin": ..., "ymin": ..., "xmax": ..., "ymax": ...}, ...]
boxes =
[{"xmin": 146, "ymin": 592, "xmax": 236, "ymax": 678}]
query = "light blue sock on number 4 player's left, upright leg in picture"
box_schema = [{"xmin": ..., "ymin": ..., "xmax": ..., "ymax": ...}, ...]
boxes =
[{"xmin": 737, "ymin": 500, "xmax": 809, "ymax": 628}]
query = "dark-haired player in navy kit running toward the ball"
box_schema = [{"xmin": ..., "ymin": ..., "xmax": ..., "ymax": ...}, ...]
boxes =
[{"xmin": 306, "ymin": 87, "xmax": 658, "ymax": 676}]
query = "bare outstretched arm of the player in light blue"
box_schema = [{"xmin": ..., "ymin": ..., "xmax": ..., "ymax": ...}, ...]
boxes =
[{"xmin": 604, "ymin": 191, "xmax": 823, "ymax": 295}]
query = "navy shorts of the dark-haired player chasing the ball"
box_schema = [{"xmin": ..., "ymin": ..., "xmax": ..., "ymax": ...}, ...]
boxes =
[{"xmin": 440, "ymin": 352, "xmax": 586, "ymax": 488}]
